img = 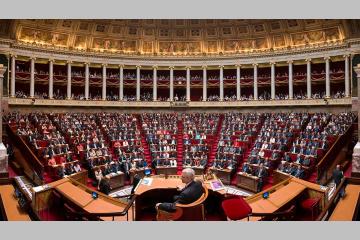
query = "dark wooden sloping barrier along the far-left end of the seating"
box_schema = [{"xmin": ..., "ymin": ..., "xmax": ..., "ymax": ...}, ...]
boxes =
[{"xmin": 6, "ymin": 124, "xmax": 44, "ymax": 176}]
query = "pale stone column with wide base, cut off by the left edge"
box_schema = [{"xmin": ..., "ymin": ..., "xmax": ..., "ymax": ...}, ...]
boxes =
[{"xmin": 0, "ymin": 64, "xmax": 9, "ymax": 178}]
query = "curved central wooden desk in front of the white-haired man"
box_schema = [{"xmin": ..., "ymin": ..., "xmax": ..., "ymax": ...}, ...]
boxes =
[{"xmin": 135, "ymin": 175, "xmax": 226, "ymax": 220}]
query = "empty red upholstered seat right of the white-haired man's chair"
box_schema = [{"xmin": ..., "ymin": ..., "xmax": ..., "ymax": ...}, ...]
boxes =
[{"xmin": 221, "ymin": 196, "xmax": 252, "ymax": 220}]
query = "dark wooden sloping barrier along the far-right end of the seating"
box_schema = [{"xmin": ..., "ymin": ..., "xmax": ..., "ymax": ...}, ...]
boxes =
[{"xmin": 315, "ymin": 125, "xmax": 353, "ymax": 182}]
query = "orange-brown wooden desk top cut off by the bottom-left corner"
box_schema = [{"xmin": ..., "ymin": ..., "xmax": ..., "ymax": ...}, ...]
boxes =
[{"xmin": 0, "ymin": 185, "xmax": 31, "ymax": 221}]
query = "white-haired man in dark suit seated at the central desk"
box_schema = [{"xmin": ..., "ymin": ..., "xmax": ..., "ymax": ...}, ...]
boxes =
[{"xmin": 156, "ymin": 168, "xmax": 204, "ymax": 212}]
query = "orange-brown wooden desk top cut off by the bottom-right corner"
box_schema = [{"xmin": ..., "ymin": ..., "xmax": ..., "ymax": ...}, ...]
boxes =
[{"xmin": 329, "ymin": 184, "xmax": 360, "ymax": 221}]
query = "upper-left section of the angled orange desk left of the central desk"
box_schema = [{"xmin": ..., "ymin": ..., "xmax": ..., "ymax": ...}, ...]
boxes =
[{"xmin": 55, "ymin": 182, "xmax": 94, "ymax": 207}]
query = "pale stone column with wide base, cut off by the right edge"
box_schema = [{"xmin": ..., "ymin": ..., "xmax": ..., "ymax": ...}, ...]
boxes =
[{"xmin": 351, "ymin": 64, "xmax": 360, "ymax": 177}]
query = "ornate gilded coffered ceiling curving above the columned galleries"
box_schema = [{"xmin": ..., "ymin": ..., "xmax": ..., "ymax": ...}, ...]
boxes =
[{"xmin": 0, "ymin": 19, "xmax": 360, "ymax": 55}]
